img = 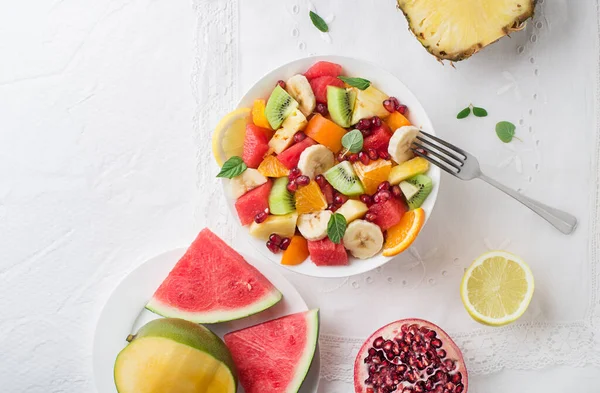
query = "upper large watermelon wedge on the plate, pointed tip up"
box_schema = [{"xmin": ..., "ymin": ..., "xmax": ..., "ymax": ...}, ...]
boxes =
[{"xmin": 146, "ymin": 228, "xmax": 281, "ymax": 323}]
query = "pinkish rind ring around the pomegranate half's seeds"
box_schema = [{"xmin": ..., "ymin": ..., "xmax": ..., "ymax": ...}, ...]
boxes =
[{"xmin": 354, "ymin": 318, "xmax": 469, "ymax": 393}]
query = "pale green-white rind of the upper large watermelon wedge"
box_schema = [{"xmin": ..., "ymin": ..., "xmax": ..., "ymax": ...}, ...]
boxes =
[{"xmin": 146, "ymin": 288, "xmax": 283, "ymax": 323}]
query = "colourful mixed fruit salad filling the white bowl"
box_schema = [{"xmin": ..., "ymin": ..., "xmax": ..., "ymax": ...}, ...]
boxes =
[{"xmin": 213, "ymin": 61, "xmax": 433, "ymax": 266}]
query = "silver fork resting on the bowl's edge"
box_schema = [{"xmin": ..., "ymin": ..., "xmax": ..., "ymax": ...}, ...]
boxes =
[{"xmin": 411, "ymin": 131, "xmax": 577, "ymax": 235}]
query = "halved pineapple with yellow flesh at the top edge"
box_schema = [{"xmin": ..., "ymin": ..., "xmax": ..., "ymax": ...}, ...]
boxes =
[{"xmin": 398, "ymin": 0, "xmax": 537, "ymax": 61}]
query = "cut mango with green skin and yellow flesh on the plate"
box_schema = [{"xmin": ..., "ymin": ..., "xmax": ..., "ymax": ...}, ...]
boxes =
[{"xmin": 114, "ymin": 318, "xmax": 237, "ymax": 393}]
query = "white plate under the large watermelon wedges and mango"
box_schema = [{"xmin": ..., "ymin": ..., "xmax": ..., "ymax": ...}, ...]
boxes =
[{"xmin": 93, "ymin": 248, "xmax": 320, "ymax": 393}]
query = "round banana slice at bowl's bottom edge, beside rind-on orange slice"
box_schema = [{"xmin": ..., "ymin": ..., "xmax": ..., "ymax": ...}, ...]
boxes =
[{"xmin": 344, "ymin": 220, "xmax": 383, "ymax": 259}]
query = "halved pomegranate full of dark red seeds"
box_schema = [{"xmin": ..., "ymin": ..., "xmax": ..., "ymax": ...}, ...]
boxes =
[{"xmin": 354, "ymin": 319, "xmax": 469, "ymax": 393}]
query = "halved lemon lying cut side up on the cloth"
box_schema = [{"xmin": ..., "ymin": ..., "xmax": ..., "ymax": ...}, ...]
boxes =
[{"xmin": 460, "ymin": 251, "xmax": 534, "ymax": 326}]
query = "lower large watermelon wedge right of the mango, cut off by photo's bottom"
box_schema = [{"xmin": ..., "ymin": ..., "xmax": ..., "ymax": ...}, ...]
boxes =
[{"xmin": 223, "ymin": 310, "xmax": 319, "ymax": 393}]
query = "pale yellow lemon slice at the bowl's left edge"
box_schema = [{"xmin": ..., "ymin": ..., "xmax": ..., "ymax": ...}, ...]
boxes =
[{"xmin": 212, "ymin": 108, "xmax": 250, "ymax": 166}]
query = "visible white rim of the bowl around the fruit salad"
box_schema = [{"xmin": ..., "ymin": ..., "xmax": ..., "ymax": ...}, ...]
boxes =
[{"xmin": 223, "ymin": 56, "xmax": 440, "ymax": 277}]
